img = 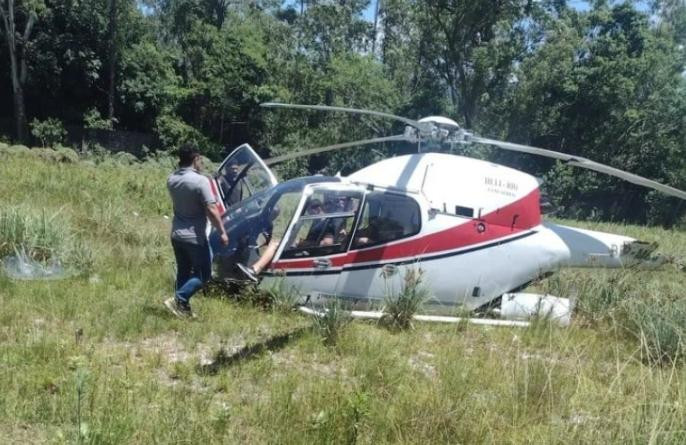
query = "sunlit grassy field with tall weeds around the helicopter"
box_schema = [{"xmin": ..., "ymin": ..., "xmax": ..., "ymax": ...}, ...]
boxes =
[{"xmin": 0, "ymin": 150, "xmax": 686, "ymax": 444}]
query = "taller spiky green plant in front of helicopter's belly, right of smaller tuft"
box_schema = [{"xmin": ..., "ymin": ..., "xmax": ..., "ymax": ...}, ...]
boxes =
[{"xmin": 379, "ymin": 268, "xmax": 429, "ymax": 329}]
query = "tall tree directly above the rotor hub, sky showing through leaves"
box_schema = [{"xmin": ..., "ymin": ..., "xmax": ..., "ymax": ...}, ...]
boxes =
[{"xmin": 415, "ymin": 0, "xmax": 529, "ymax": 128}]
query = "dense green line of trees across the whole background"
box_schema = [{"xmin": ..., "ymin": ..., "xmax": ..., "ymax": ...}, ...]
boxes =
[{"xmin": 0, "ymin": 0, "xmax": 686, "ymax": 224}]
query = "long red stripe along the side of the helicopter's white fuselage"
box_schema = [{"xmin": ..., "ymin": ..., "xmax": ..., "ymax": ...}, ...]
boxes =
[{"xmin": 270, "ymin": 188, "xmax": 541, "ymax": 269}]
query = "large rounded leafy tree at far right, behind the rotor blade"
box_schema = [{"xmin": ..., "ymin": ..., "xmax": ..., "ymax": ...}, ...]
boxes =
[{"xmin": 494, "ymin": 4, "xmax": 686, "ymax": 224}]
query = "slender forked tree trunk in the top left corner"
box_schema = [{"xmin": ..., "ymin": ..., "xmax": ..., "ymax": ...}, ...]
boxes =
[{"xmin": 0, "ymin": 0, "xmax": 44, "ymax": 142}]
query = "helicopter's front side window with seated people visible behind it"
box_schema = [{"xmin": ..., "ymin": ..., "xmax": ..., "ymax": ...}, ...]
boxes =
[{"xmin": 282, "ymin": 191, "xmax": 362, "ymax": 258}]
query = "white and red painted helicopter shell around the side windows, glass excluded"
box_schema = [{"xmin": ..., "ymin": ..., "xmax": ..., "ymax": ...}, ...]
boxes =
[{"xmin": 212, "ymin": 149, "xmax": 660, "ymax": 309}]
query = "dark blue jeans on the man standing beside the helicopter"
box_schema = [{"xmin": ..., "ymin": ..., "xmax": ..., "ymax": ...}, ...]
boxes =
[{"xmin": 172, "ymin": 239, "xmax": 212, "ymax": 304}]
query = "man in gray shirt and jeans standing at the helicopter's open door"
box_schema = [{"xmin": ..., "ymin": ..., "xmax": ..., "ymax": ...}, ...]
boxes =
[{"xmin": 164, "ymin": 145, "xmax": 229, "ymax": 317}]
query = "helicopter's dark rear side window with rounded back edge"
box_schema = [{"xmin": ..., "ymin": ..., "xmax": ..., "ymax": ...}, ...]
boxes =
[{"xmin": 353, "ymin": 192, "xmax": 421, "ymax": 249}]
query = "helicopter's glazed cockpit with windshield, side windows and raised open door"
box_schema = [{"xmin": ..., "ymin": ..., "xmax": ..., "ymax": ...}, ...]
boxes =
[{"xmin": 210, "ymin": 144, "xmax": 428, "ymax": 279}]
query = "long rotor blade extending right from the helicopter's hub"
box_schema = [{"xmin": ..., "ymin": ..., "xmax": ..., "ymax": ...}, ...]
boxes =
[{"xmin": 470, "ymin": 136, "xmax": 686, "ymax": 199}]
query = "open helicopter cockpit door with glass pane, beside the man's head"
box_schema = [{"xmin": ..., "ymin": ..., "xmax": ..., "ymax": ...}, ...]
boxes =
[{"xmin": 214, "ymin": 144, "xmax": 279, "ymax": 209}]
